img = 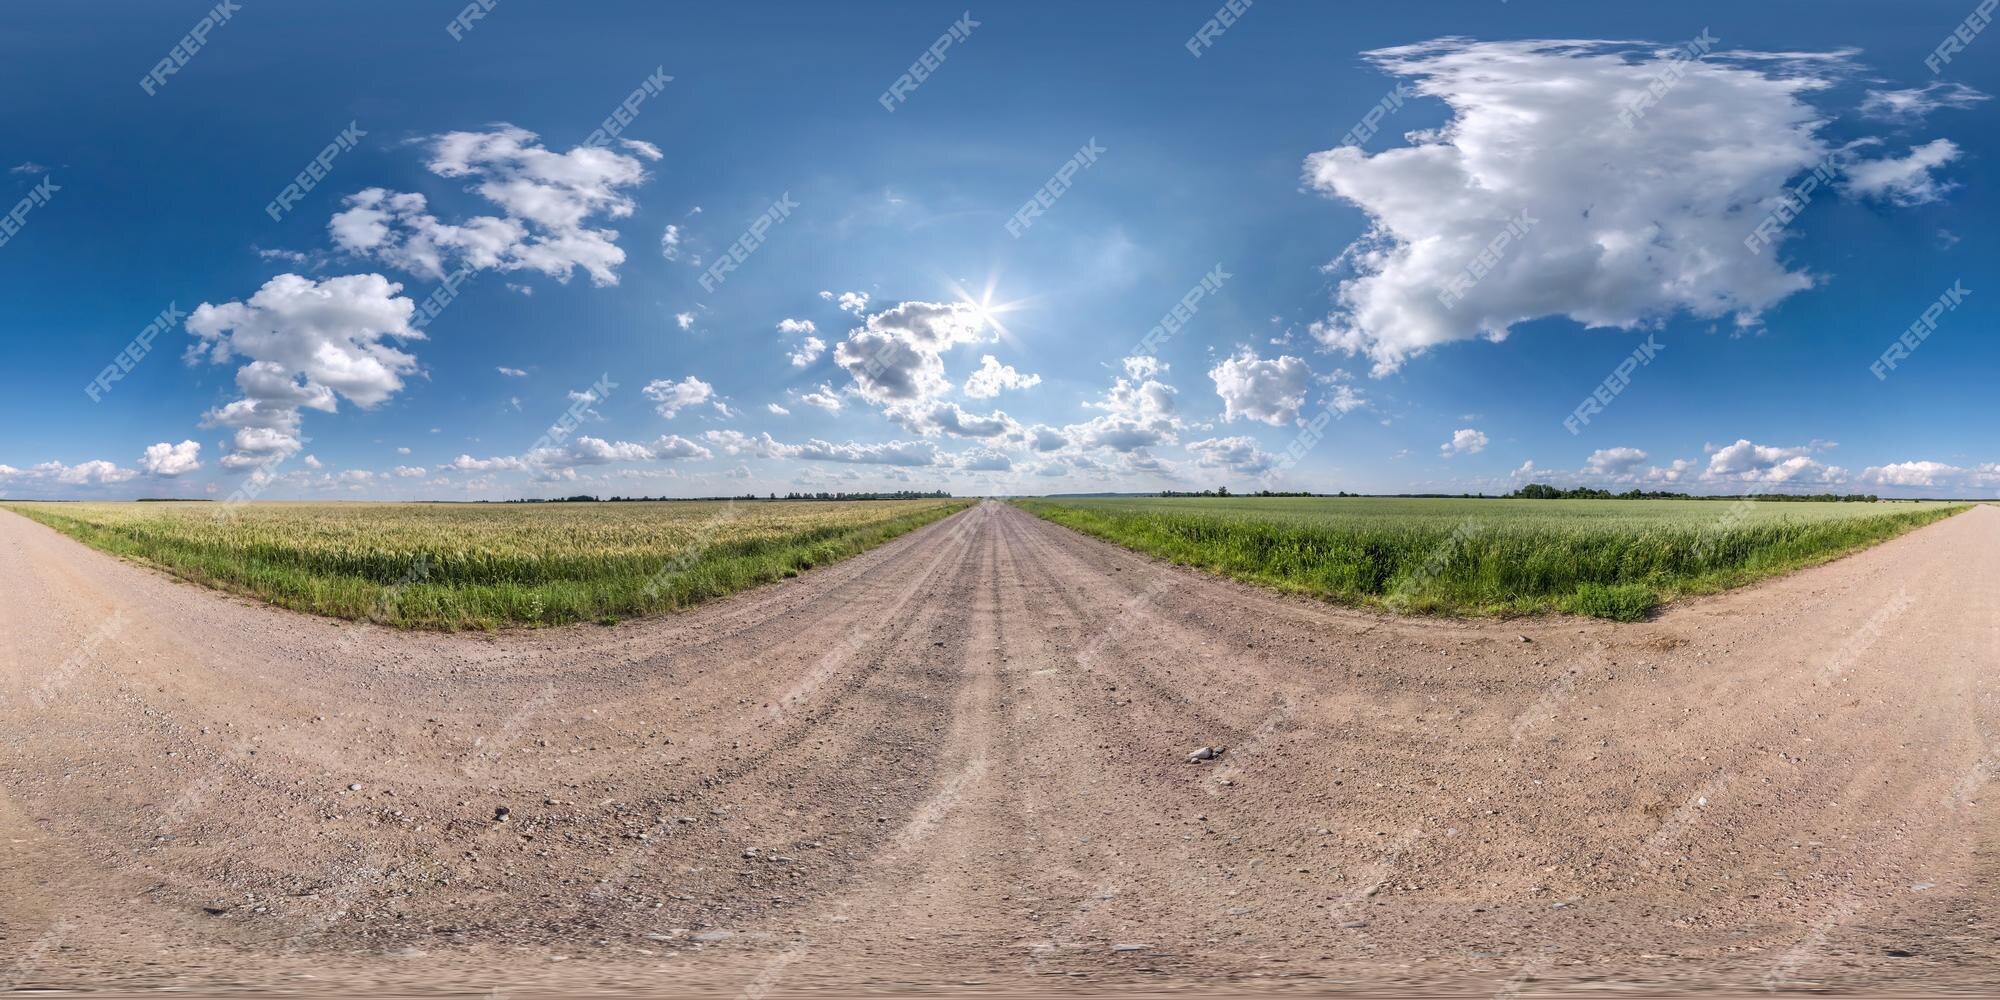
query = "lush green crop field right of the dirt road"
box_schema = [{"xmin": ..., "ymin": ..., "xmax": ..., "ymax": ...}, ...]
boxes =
[{"xmin": 1016, "ymin": 496, "xmax": 1966, "ymax": 620}]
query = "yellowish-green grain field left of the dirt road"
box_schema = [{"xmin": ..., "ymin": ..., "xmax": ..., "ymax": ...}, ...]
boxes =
[{"xmin": 4, "ymin": 500, "xmax": 970, "ymax": 628}]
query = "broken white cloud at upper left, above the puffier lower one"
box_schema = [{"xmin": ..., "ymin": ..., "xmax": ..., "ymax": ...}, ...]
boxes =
[{"xmin": 328, "ymin": 124, "xmax": 658, "ymax": 286}]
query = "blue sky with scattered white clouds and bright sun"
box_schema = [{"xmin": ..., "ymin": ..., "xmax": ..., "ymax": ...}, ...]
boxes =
[{"xmin": 0, "ymin": 0, "xmax": 2000, "ymax": 498}]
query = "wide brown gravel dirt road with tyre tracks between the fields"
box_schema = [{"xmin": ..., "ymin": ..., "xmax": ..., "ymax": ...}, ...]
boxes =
[{"xmin": 0, "ymin": 504, "xmax": 2000, "ymax": 996}]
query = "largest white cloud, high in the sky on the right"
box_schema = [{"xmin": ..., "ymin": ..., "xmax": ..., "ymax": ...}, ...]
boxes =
[{"xmin": 1306, "ymin": 38, "xmax": 1960, "ymax": 374}]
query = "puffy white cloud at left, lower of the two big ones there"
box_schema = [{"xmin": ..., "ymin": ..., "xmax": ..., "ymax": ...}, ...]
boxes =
[{"xmin": 188, "ymin": 274, "xmax": 424, "ymax": 470}]
